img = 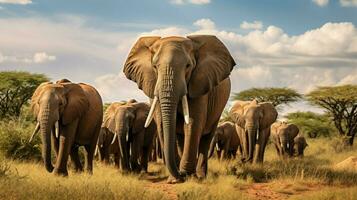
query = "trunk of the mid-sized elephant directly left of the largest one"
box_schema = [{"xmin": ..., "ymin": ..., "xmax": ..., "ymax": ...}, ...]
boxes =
[{"xmin": 114, "ymin": 113, "xmax": 130, "ymax": 171}]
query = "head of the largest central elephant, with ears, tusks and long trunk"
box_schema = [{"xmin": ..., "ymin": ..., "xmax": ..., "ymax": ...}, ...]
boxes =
[{"xmin": 123, "ymin": 35, "xmax": 235, "ymax": 178}]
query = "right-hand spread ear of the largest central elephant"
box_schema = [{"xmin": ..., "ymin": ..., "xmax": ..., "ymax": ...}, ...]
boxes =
[{"xmin": 187, "ymin": 35, "xmax": 236, "ymax": 98}]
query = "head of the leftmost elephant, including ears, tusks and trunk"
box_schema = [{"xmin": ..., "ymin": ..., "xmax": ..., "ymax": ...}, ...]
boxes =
[{"xmin": 30, "ymin": 80, "xmax": 89, "ymax": 172}]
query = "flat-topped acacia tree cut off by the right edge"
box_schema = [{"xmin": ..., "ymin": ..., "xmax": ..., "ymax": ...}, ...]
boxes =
[{"xmin": 306, "ymin": 85, "xmax": 357, "ymax": 146}]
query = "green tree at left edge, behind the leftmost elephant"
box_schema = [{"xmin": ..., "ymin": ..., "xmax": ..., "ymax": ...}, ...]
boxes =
[{"xmin": 0, "ymin": 71, "xmax": 48, "ymax": 119}]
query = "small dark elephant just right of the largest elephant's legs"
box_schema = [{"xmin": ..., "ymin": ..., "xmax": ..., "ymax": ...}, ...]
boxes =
[{"xmin": 208, "ymin": 122, "xmax": 242, "ymax": 160}]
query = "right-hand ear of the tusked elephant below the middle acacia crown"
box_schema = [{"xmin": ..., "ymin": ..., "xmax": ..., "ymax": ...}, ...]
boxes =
[{"xmin": 259, "ymin": 103, "xmax": 278, "ymax": 129}]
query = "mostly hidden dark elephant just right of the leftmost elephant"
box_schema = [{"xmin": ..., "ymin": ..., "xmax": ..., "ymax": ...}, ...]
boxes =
[{"xmin": 97, "ymin": 127, "xmax": 120, "ymax": 168}]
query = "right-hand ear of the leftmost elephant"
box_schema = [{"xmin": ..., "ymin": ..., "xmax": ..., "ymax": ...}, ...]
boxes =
[{"xmin": 61, "ymin": 83, "xmax": 89, "ymax": 125}]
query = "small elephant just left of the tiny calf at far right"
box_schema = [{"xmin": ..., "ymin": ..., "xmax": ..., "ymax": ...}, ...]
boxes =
[{"xmin": 271, "ymin": 121, "xmax": 299, "ymax": 157}]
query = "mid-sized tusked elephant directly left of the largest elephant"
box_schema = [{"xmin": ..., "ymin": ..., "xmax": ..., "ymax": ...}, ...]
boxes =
[{"xmin": 102, "ymin": 101, "xmax": 156, "ymax": 172}]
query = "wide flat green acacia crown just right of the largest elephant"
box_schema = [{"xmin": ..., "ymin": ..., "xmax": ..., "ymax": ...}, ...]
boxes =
[{"xmin": 233, "ymin": 87, "xmax": 302, "ymax": 107}]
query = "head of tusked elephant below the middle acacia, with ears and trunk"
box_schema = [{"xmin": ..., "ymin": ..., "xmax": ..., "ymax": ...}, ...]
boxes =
[{"xmin": 230, "ymin": 100, "xmax": 278, "ymax": 161}]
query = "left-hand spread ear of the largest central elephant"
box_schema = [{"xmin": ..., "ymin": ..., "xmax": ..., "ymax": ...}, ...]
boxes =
[{"xmin": 123, "ymin": 37, "xmax": 160, "ymax": 98}]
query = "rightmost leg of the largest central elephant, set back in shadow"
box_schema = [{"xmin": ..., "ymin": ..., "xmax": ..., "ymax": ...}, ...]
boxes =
[{"xmin": 196, "ymin": 130, "xmax": 211, "ymax": 178}]
